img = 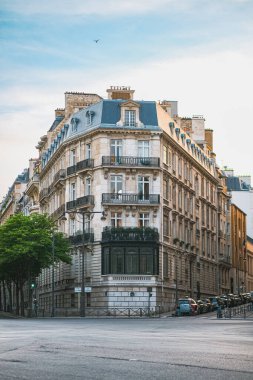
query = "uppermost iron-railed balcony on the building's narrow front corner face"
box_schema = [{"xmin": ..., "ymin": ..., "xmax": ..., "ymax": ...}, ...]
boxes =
[{"xmin": 102, "ymin": 156, "xmax": 160, "ymax": 168}]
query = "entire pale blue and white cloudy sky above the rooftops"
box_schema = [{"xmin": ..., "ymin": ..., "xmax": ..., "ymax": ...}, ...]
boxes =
[{"xmin": 0, "ymin": 0, "xmax": 253, "ymax": 201}]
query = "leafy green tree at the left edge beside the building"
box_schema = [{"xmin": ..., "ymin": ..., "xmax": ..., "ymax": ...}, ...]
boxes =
[{"xmin": 0, "ymin": 214, "xmax": 71, "ymax": 315}]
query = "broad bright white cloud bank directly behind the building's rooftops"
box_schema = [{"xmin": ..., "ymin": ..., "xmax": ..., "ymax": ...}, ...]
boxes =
[{"xmin": 0, "ymin": 27, "xmax": 253, "ymax": 198}]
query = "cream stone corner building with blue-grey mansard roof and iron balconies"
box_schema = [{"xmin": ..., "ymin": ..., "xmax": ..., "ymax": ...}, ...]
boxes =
[{"xmin": 38, "ymin": 87, "xmax": 224, "ymax": 315}]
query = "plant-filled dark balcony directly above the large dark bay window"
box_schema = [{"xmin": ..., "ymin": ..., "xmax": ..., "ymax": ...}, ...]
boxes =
[{"xmin": 102, "ymin": 227, "xmax": 159, "ymax": 243}]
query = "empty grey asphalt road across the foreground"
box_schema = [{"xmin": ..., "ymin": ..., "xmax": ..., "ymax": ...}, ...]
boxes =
[{"xmin": 0, "ymin": 317, "xmax": 253, "ymax": 380}]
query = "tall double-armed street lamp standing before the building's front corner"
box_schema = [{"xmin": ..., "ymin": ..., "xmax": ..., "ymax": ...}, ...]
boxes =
[{"xmin": 62, "ymin": 210, "xmax": 106, "ymax": 317}]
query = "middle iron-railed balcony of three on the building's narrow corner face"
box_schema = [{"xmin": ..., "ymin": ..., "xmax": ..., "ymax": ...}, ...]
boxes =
[{"xmin": 102, "ymin": 193, "xmax": 160, "ymax": 205}]
